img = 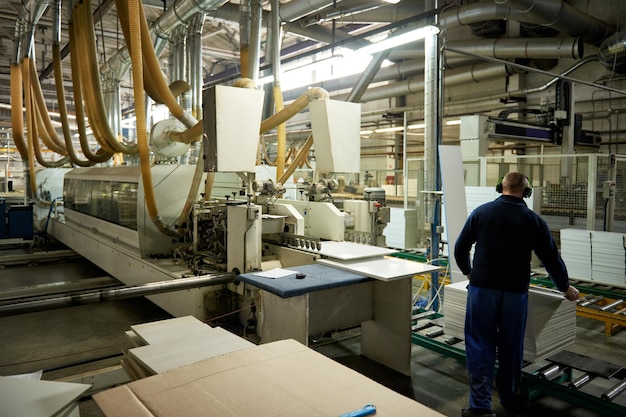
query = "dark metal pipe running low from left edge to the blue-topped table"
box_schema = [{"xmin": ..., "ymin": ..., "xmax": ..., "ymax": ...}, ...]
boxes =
[{"xmin": 0, "ymin": 272, "xmax": 235, "ymax": 316}]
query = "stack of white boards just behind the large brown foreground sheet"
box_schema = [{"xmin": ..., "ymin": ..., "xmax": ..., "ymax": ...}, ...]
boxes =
[{"xmin": 122, "ymin": 316, "xmax": 254, "ymax": 380}]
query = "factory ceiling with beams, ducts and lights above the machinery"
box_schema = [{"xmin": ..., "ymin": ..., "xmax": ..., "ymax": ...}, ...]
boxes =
[{"xmin": 0, "ymin": 0, "xmax": 626, "ymax": 146}]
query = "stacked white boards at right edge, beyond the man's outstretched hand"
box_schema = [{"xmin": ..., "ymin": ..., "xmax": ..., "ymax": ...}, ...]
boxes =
[{"xmin": 561, "ymin": 229, "xmax": 626, "ymax": 286}]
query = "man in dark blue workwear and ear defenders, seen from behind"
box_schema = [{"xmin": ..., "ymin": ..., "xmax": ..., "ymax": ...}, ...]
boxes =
[{"xmin": 454, "ymin": 172, "xmax": 579, "ymax": 417}]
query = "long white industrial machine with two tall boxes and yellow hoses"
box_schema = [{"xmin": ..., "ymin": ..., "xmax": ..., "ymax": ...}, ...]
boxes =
[{"xmin": 36, "ymin": 86, "xmax": 388, "ymax": 328}]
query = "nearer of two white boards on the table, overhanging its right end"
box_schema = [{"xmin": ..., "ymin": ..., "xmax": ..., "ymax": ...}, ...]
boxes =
[{"xmin": 317, "ymin": 258, "xmax": 445, "ymax": 281}]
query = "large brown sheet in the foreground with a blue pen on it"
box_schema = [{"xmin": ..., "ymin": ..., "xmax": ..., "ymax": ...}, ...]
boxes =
[{"xmin": 93, "ymin": 340, "xmax": 443, "ymax": 417}]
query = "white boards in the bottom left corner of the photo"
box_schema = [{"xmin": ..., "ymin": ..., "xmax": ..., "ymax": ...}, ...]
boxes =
[{"xmin": 0, "ymin": 376, "xmax": 91, "ymax": 417}]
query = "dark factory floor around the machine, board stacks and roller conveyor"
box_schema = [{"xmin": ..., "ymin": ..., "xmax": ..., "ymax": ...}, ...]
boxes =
[{"xmin": 0, "ymin": 247, "xmax": 626, "ymax": 417}]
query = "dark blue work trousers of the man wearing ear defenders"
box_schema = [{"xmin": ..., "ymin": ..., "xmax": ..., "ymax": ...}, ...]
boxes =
[{"xmin": 465, "ymin": 285, "xmax": 528, "ymax": 410}]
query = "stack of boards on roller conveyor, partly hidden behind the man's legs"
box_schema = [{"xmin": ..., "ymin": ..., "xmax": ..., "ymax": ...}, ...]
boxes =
[{"xmin": 443, "ymin": 281, "xmax": 576, "ymax": 362}]
